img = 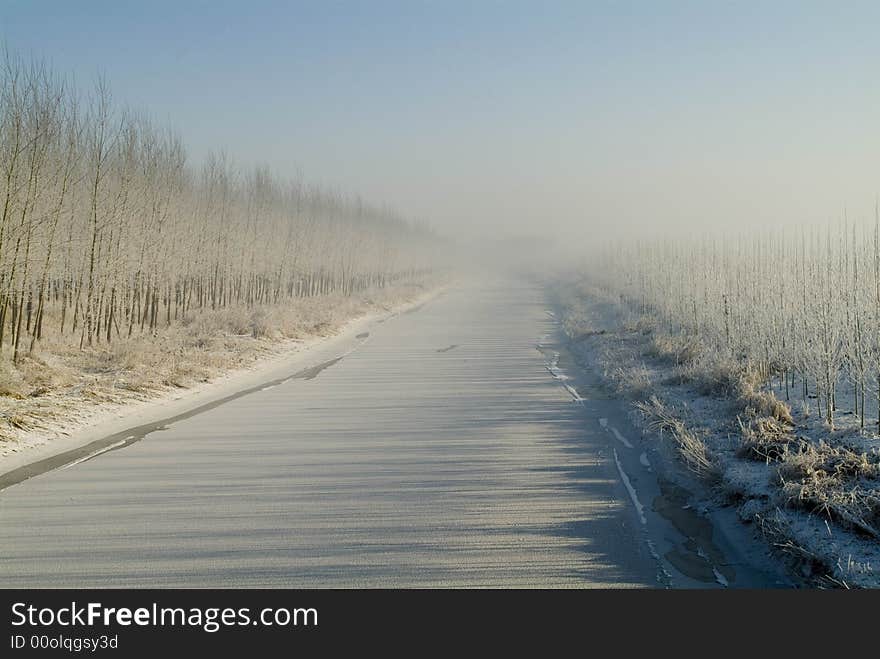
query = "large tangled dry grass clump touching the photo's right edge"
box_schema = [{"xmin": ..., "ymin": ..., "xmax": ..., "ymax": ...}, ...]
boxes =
[{"xmin": 777, "ymin": 441, "xmax": 880, "ymax": 538}]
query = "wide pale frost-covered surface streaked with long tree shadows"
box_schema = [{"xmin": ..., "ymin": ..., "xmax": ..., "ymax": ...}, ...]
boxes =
[{"xmin": 0, "ymin": 280, "xmax": 659, "ymax": 587}]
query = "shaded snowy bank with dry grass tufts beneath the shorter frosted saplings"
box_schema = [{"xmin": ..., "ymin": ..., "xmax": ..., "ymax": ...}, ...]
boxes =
[{"xmin": 554, "ymin": 282, "xmax": 880, "ymax": 588}]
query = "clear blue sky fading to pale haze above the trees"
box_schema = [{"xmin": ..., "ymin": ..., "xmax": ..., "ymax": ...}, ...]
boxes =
[{"xmin": 0, "ymin": 0, "xmax": 880, "ymax": 244}]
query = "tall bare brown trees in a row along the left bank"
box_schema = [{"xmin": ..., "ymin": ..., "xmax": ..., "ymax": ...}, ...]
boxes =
[{"xmin": 0, "ymin": 53, "xmax": 436, "ymax": 359}]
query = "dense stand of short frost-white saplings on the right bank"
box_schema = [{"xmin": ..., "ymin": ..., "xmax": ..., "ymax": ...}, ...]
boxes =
[{"xmin": 590, "ymin": 218, "xmax": 880, "ymax": 428}]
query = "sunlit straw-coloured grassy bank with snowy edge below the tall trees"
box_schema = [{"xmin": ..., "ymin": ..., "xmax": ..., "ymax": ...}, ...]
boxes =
[{"xmin": 0, "ymin": 281, "xmax": 444, "ymax": 474}]
